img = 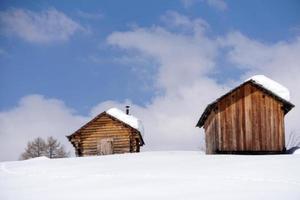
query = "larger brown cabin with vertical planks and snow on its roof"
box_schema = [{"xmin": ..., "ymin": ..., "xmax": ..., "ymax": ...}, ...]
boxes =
[{"xmin": 196, "ymin": 75, "xmax": 294, "ymax": 154}]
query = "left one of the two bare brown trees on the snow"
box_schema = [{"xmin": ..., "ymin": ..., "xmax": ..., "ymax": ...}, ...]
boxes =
[{"xmin": 20, "ymin": 137, "xmax": 46, "ymax": 160}]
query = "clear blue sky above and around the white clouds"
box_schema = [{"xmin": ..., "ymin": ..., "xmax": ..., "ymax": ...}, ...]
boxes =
[{"xmin": 0, "ymin": 1, "xmax": 300, "ymax": 114}]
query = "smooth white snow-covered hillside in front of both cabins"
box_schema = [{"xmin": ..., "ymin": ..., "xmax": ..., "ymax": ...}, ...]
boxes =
[{"xmin": 0, "ymin": 152, "xmax": 300, "ymax": 200}]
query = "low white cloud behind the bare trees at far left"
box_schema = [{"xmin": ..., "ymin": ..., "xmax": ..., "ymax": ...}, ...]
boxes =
[{"xmin": 0, "ymin": 95, "xmax": 88, "ymax": 160}]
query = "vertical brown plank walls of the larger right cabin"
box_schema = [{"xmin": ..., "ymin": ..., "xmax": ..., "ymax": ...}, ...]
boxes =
[{"xmin": 204, "ymin": 83, "xmax": 285, "ymax": 154}]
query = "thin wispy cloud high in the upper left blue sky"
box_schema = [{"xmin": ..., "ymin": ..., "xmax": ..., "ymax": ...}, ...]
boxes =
[{"xmin": 0, "ymin": 8, "xmax": 86, "ymax": 43}]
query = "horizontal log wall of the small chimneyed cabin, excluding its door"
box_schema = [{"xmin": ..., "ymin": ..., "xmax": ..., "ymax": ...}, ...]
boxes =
[{"xmin": 71, "ymin": 115, "xmax": 139, "ymax": 156}]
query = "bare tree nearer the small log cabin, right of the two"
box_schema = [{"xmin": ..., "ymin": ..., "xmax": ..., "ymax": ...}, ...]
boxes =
[{"xmin": 47, "ymin": 137, "xmax": 70, "ymax": 158}]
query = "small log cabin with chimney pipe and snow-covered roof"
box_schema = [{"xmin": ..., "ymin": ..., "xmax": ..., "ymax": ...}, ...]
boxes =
[{"xmin": 67, "ymin": 106, "xmax": 145, "ymax": 156}]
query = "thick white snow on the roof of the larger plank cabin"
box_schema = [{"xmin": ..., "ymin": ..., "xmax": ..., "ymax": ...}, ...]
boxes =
[{"xmin": 246, "ymin": 75, "xmax": 290, "ymax": 101}]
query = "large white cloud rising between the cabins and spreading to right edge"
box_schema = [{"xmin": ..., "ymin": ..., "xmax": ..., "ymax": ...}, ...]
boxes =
[{"xmin": 108, "ymin": 12, "xmax": 300, "ymax": 149}]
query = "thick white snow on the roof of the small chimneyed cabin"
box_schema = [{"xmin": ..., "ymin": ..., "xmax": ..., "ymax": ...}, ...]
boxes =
[{"xmin": 106, "ymin": 108, "xmax": 144, "ymax": 135}]
